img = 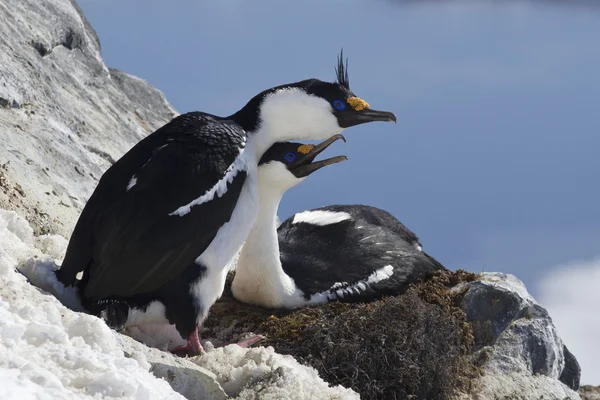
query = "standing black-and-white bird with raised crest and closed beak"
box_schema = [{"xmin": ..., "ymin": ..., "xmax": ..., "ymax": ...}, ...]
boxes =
[{"xmin": 57, "ymin": 53, "xmax": 396, "ymax": 355}]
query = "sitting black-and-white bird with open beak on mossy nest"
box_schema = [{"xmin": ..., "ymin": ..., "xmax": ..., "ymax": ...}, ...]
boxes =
[{"xmin": 231, "ymin": 135, "xmax": 445, "ymax": 308}]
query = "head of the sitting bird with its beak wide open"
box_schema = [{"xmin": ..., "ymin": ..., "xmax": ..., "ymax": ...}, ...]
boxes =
[{"xmin": 258, "ymin": 135, "xmax": 348, "ymax": 181}]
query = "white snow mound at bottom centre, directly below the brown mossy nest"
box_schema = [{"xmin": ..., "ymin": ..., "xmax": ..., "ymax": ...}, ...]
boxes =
[{"xmin": 195, "ymin": 345, "xmax": 360, "ymax": 400}]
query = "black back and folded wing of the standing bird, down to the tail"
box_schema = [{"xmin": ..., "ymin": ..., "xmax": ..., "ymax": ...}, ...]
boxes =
[{"xmin": 58, "ymin": 113, "xmax": 246, "ymax": 300}]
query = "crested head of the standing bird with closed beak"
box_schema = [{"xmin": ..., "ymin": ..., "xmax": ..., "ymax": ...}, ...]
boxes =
[{"xmin": 231, "ymin": 53, "xmax": 396, "ymax": 142}]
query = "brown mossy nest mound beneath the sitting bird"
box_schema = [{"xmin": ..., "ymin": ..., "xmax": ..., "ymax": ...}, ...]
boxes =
[{"xmin": 203, "ymin": 270, "xmax": 478, "ymax": 399}]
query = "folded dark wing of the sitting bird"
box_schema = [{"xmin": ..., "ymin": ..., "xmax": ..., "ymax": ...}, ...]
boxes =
[{"xmin": 278, "ymin": 219, "xmax": 422, "ymax": 297}]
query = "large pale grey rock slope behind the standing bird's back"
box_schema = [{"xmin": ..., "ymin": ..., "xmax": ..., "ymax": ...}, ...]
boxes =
[{"xmin": 0, "ymin": 0, "xmax": 177, "ymax": 237}]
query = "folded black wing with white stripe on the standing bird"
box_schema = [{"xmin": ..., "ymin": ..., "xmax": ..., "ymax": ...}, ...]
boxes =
[{"xmin": 85, "ymin": 119, "xmax": 246, "ymax": 299}]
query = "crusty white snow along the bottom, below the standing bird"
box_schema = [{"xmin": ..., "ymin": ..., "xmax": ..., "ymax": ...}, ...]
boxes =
[{"xmin": 0, "ymin": 209, "xmax": 359, "ymax": 400}]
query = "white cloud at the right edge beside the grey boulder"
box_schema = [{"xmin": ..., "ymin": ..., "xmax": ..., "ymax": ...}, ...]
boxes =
[{"xmin": 537, "ymin": 257, "xmax": 600, "ymax": 385}]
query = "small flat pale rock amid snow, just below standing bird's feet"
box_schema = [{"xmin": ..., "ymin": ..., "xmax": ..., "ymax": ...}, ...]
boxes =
[{"xmin": 115, "ymin": 332, "xmax": 228, "ymax": 400}]
